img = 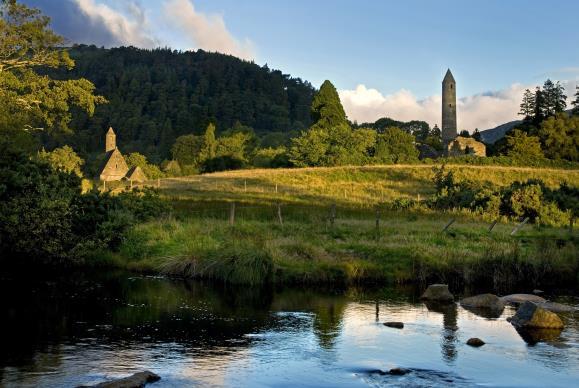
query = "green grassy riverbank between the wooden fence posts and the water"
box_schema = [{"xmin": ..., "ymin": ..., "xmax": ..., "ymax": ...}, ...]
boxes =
[{"xmin": 94, "ymin": 206, "xmax": 579, "ymax": 290}]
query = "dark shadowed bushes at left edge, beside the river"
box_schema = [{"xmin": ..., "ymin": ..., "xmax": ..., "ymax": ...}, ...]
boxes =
[{"xmin": 0, "ymin": 152, "xmax": 167, "ymax": 262}]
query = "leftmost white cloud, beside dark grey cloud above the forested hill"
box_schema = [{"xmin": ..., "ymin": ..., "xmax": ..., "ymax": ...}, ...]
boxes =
[{"xmin": 74, "ymin": 0, "xmax": 160, "ymax": 48}]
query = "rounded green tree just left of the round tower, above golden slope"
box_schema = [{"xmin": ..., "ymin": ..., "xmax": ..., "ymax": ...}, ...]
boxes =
[{"xmin": 374, "ymin": 127, "xmax": 419, "ymax": 164}]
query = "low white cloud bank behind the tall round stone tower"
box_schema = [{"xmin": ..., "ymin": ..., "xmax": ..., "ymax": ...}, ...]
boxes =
[{"xmin": 339, "ymin": 81, "xmax": 577, "ymax": 132}]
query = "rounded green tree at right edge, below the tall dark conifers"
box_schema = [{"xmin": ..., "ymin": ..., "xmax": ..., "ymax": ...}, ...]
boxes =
[{"xmin": 539, "ymin": 113, "xmax": 579, "ymax": 161}]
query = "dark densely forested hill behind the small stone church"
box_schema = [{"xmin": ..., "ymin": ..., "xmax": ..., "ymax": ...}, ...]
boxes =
[{"xmin": 48, "ymin": 46, "xmax": 315, "ymax": 161}]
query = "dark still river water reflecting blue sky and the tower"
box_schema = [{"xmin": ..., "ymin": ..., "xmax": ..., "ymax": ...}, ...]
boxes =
[{"xmin": 0, "ymin": 273, "xmax": 579, "ymax": 387}]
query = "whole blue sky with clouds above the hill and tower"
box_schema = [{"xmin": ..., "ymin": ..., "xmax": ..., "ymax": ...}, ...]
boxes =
[{"xmin": 21, "ymin": 0, "xmax": 579, "ymax": 131}]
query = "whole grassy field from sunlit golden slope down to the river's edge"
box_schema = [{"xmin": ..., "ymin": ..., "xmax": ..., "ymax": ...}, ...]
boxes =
[{"xmin": 102, "ymin": 165, "xmax": 579, "ymax": 289}]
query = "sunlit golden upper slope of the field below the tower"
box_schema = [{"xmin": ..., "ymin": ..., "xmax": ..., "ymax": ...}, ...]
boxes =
[{"xmin": 161, "ymin": 165, "xmax": 579, "ymax": 207}]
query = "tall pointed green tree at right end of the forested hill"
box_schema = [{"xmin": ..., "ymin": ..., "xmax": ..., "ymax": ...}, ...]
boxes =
[{"xmin": 311, "ymin": 80, "xmax": 348, "ymax": 129}]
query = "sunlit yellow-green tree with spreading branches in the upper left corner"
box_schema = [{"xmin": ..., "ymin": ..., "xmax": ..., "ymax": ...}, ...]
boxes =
[{"xmin": 0, "ymin": 0, "xmax": 106, "ymax": 132}]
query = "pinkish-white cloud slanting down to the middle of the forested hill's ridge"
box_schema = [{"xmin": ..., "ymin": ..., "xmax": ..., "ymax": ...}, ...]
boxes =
[{"xmin": 164, "ymin": 0, "xmax": 254, "ymax": 59}]
